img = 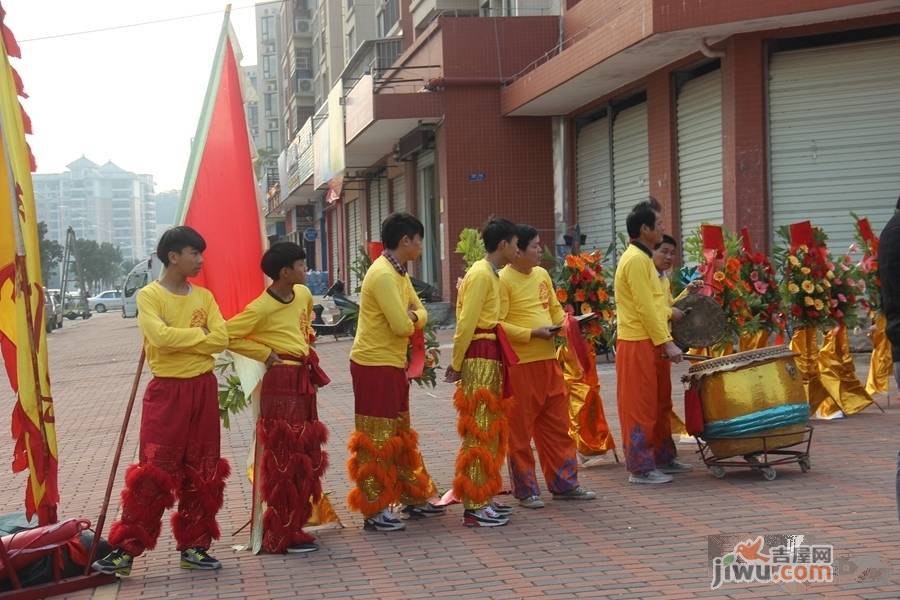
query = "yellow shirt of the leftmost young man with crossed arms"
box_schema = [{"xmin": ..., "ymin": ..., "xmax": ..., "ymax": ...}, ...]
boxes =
[{"xmin": 137, "ymin": 281, "xmax": 228, "ymax": 379}]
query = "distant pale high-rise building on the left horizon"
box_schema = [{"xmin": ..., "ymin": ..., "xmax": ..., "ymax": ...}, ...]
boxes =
[{"xmin": 33, "ymin": 156, "xmax": 157, "ymax": 261}]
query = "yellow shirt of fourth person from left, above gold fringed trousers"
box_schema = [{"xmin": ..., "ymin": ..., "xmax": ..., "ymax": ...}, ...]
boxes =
[{"xmin": 451, "ymin": 258, "xmax": 501, "ymax": 371}]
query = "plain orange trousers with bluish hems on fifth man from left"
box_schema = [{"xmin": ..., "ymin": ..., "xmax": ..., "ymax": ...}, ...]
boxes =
[{"xmin": 508, "ymin": 359, "xmax": 578, "ymax": 500}]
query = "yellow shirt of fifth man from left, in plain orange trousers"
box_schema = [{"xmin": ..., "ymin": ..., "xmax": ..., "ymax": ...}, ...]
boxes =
[{"xmin": 500, "ymin": 266, "xmax": 566, "ymax": 363}]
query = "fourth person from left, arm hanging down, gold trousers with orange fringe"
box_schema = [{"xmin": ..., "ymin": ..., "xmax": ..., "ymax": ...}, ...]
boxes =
[{"xmin": 445, "ymin": 219, "xmax": 518, "ymax": 527}]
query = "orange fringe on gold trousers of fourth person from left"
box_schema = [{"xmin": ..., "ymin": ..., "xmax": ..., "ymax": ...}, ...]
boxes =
[{"xmin": 453, "ymin": 388, "xmax": 512, "ymax": 507}]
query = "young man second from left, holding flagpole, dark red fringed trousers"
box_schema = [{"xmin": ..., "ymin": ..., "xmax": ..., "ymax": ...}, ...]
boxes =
[{"xmin": 228, "ymin": 242, "xmax": 330, "ymax": 554}]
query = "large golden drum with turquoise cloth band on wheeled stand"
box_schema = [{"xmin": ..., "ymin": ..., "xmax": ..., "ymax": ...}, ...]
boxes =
[{"xmin": 688, "ymin": 346, "xmax": 809, "ymax": 458}]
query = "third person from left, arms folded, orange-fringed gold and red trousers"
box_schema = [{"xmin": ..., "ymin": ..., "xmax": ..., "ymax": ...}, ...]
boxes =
[{"xmin": 347, "ymin": 213, "xmax": 444, "ymax": 531}]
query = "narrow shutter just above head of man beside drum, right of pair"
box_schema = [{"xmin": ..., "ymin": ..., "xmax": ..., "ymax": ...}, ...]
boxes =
[{"xmin": 613, "ymin": 102, "xmax": 650, "ymax": 243}]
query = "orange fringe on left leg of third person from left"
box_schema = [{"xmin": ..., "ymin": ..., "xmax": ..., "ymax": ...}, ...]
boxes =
[{"xmin": 347, "ymin": 431, "xmax": 404, "ymax": 518}]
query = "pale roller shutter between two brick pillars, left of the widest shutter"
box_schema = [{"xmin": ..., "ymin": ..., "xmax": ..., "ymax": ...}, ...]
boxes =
[{"xmin": 677, "ymin": 70, "xmax": 723, "ymax": 248}]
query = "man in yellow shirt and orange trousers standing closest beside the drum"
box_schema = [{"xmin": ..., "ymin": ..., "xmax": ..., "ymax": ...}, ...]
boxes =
[{"xmin": 615, "ymin": 202, "xmax": 684, "ymax": 484}]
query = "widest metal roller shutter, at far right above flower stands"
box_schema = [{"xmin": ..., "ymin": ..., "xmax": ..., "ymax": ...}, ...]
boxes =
[{"xmin": 769, "ymin": 38, "xmax": 900, "ymax": 253}]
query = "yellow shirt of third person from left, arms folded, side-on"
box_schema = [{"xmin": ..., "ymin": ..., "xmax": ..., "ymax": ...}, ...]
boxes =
[{"xmin": 350, "ymin": 256, "xmax": 428, "ymax": 369}]
